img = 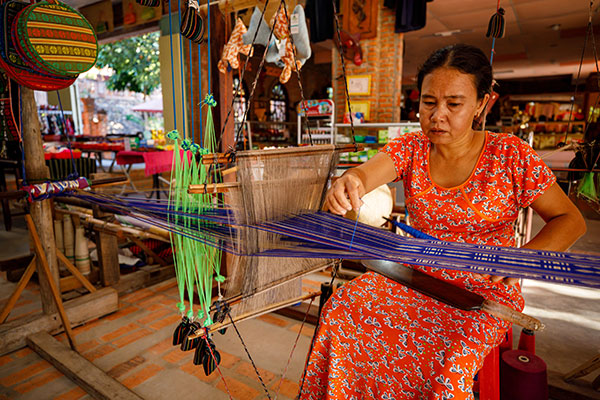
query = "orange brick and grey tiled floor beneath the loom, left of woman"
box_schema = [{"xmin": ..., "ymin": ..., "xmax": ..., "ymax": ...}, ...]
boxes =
[{"xmin": 0, "ymin": 279, "xmax": 314, "ymax": 400}]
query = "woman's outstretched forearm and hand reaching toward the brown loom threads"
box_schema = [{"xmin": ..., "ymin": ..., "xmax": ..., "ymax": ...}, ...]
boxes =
[{"xmin": 324, "ymin": 153, "xmax": 396, "ymax": 215}]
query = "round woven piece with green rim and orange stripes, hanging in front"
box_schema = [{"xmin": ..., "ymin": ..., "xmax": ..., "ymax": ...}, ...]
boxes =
[{"xmin": 13, "ymin": 0, "xmax": 98, "ymax": 77}]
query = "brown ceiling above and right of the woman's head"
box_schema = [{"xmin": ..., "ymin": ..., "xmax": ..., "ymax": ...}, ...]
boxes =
[{"xmin": 403, "ymin": 0, "xmax": 600, "ymax": 84}]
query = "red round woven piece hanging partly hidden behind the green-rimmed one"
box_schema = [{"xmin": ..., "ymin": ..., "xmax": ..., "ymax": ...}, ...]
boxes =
[{"xmin": 0, "ymin": 1, "xmax": 75, "ymax": 91}]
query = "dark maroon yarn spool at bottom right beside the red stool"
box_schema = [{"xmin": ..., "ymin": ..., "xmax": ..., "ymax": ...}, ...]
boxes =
[{"xmin": 500, "ymin": 350, "xmax": 548, "ymax": 400}]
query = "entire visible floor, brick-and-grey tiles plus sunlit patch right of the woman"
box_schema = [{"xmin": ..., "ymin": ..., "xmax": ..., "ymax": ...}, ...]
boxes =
[{"xmin": 0, "ymin": 206, "xmax": 600, "ymax": 400}]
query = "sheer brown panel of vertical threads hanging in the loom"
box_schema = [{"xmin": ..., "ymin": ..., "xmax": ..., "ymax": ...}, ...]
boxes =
[{"xmin": 226, "ymin": 146, "xmax": 338, "ymax": 315}]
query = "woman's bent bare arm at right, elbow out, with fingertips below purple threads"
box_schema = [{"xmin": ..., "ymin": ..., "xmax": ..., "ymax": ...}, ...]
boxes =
[{"xmin": 490, "ymin": 183, "xmax": 586, "ymax": 285}]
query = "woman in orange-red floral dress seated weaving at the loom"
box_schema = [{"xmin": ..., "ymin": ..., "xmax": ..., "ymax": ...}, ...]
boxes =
[{"xmin": 300, "ymin": 45, "xmax": 585, "ymax": 399}]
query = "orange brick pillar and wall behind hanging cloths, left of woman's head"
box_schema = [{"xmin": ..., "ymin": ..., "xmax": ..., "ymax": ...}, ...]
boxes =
[{"xmin": 332, "ymin": 0, "xmax": 404, "ymax": 122}]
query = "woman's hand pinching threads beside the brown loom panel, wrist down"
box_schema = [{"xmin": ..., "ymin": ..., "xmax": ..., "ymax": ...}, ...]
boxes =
[{"xmin": 323, "ymin": 170, "xmax": 365, "ymax": 215}]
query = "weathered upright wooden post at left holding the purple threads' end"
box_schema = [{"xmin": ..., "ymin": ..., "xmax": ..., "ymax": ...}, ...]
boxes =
[{"xmin": 21, "ymin": 87, "xmax": 58, "ymax": 314}]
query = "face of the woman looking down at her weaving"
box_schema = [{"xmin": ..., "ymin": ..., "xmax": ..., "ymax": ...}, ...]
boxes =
[{"xmin": 419, "ymin": 67, "xmax": 489, "ymax": 144}]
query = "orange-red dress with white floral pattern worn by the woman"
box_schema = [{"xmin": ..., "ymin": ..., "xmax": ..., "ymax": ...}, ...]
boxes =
[{"xmin": 300, "ymin": 132, "xmax": 556, "ymax": 399}]
